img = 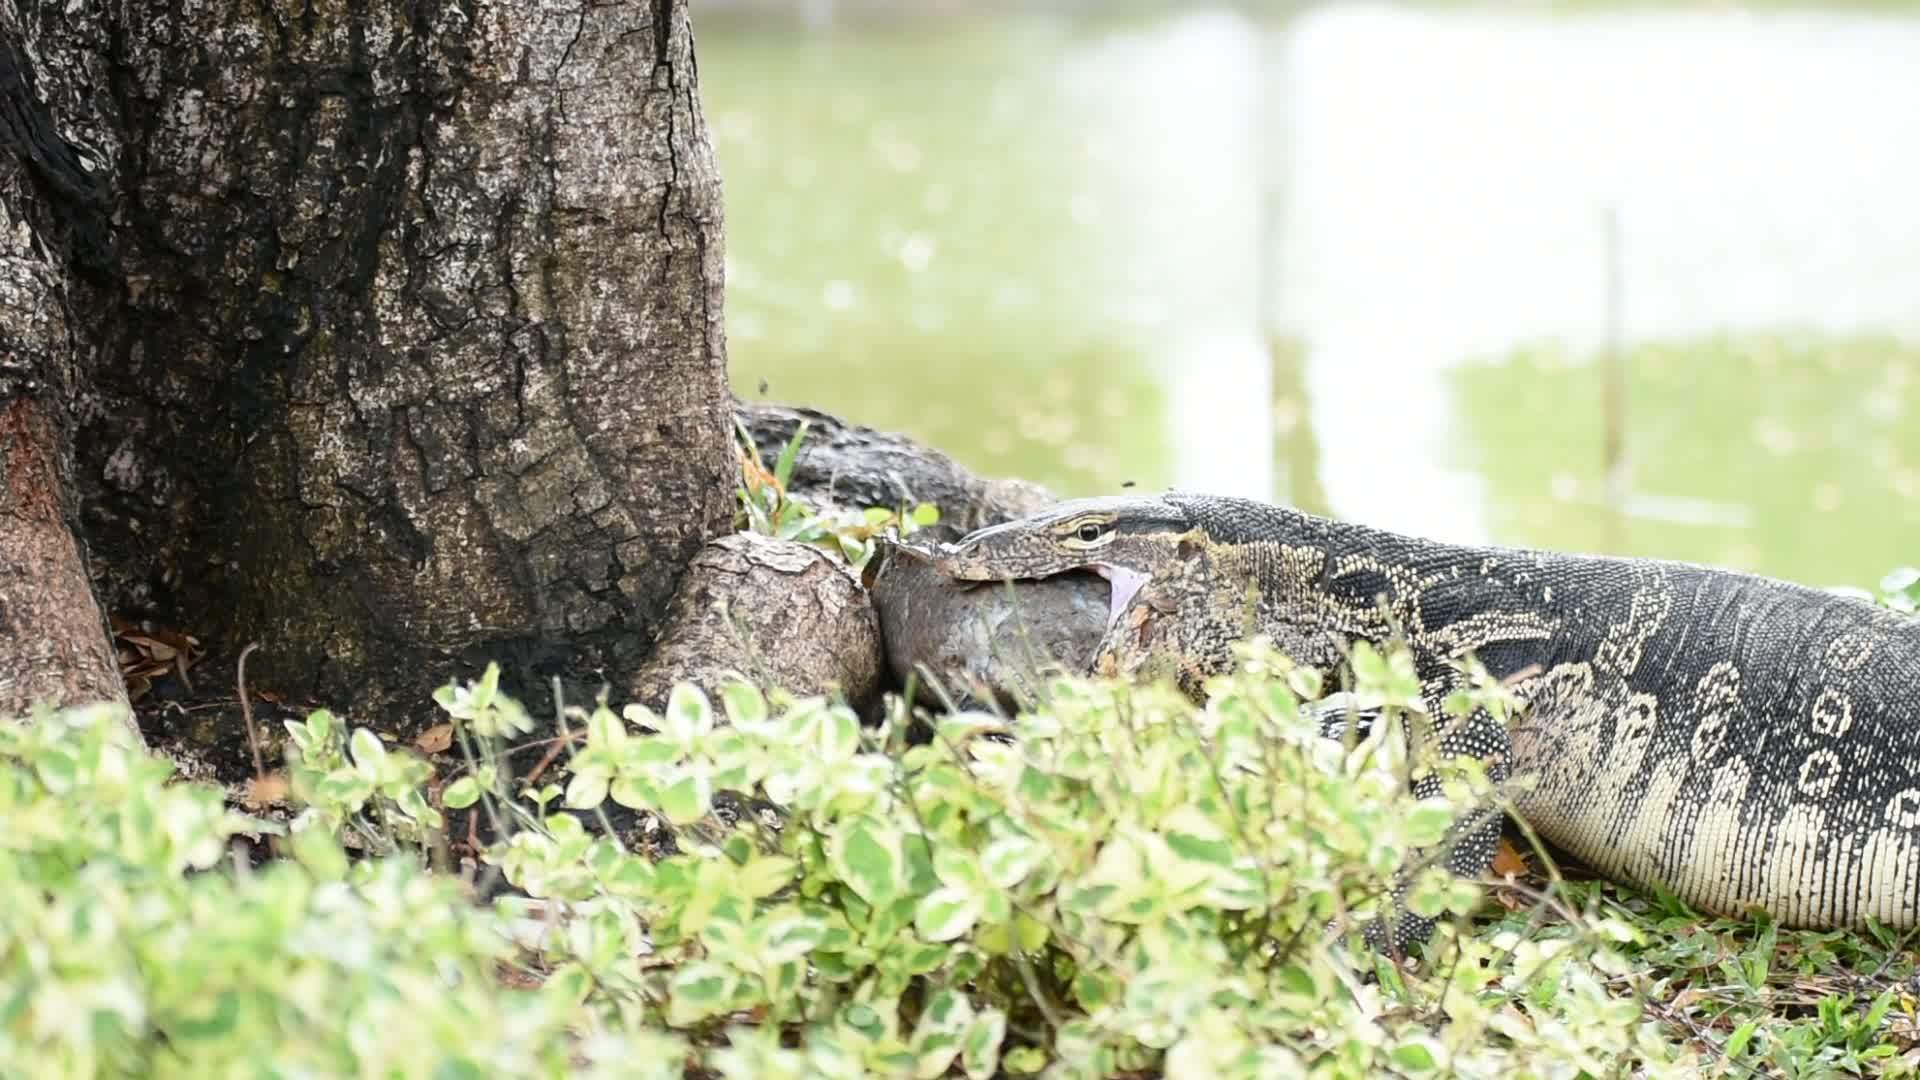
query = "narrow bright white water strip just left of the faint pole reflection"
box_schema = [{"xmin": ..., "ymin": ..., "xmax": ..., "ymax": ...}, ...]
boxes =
[{"xmin": 1064, "ymin": 12, "xmax": 1275, "ymax": 498}]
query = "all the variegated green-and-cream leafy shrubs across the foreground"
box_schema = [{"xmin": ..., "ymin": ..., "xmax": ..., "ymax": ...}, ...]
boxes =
[{"xmin": 0, "ymin": 644, "xmax": 1695, "ymax": 1078}]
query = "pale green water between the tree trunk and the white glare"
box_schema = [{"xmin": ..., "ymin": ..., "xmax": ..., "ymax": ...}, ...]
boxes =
[{"xmin": 699, "ymin": 15, "xmax": 1169, "ymax": 492}]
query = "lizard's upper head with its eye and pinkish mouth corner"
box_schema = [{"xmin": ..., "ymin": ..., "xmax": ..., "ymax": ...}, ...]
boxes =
[{"xmin": 931, "ymin": 496, "xmax": 1198, "ymax": 626}]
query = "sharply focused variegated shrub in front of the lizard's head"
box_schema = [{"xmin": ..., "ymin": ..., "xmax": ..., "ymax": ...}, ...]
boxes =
[{"xmin": 499, "ymin": 634, "xmax": 1676, "ymax": 1076}]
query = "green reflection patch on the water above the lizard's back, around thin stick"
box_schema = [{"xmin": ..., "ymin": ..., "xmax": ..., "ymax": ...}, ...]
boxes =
[{"xmin": 1455, "ymin": 334, "xmax": 1920, "ymax": 584}]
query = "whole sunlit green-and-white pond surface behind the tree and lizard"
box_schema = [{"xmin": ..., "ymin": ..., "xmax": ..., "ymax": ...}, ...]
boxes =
[{"xmin": 699, "ymin": 6, "xmax": 1920, "ymax": 582}]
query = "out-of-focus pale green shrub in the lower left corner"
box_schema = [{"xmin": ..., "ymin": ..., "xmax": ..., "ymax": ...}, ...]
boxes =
[{"xmin": 0, "ymin": 691, "xmax": 684, "ymax": 1080}]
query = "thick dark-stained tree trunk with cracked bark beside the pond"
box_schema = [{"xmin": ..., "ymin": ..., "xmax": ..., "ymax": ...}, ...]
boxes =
[{"xmin": 0, "ymin": 0, "xmax": 733, "ymax": 721}]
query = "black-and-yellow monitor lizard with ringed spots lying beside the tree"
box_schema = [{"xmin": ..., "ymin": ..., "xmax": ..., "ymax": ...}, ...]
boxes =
[{"xmin": 935, "ymin": 494, "xmax": 1920, "ymax": 936}]
